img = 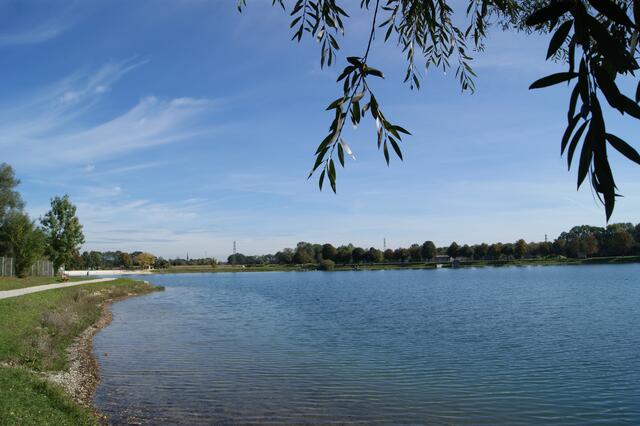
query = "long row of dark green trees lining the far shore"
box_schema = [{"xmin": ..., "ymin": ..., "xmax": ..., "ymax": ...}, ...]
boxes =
[{"xmin": 227, "ymin": 223, "xmax": 640, "ymax": 269}]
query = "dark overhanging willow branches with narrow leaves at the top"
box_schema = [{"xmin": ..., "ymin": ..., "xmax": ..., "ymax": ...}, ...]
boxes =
[{"xmin": 237, "ymin": 0, "xmax": 640, "ymax": 220}]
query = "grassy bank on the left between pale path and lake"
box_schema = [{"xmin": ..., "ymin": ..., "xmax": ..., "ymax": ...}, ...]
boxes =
[{"xmin": 0, "ymin": 279, "xmax": 162, "ymax": 424}]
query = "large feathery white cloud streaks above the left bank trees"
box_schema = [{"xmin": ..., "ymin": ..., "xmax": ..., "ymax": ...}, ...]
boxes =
[{"xmin": 0, "ymin": 61, "xmax": 219, "ymax": 171}]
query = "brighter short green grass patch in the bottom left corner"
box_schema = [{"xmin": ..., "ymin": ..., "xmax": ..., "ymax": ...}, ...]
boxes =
[{"xmin": 0, "ymin": 368, "xmax": 96, "ymax": 425}]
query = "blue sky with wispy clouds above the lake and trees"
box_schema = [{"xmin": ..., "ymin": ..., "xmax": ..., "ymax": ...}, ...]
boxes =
[{"xmin": 0, "ymin": 0, "xmax": 640, "ymax": 258}]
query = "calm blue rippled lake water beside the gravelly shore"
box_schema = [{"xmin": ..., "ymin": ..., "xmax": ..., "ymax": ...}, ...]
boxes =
[{"xmin": 94, "ymin": 265, "xmax": 640, "ymax": 425}]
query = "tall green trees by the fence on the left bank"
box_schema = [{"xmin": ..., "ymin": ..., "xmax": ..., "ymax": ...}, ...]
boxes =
[{"xmin": 0, "ymin": 163, "xmax": 84, "ymax": 277}]
